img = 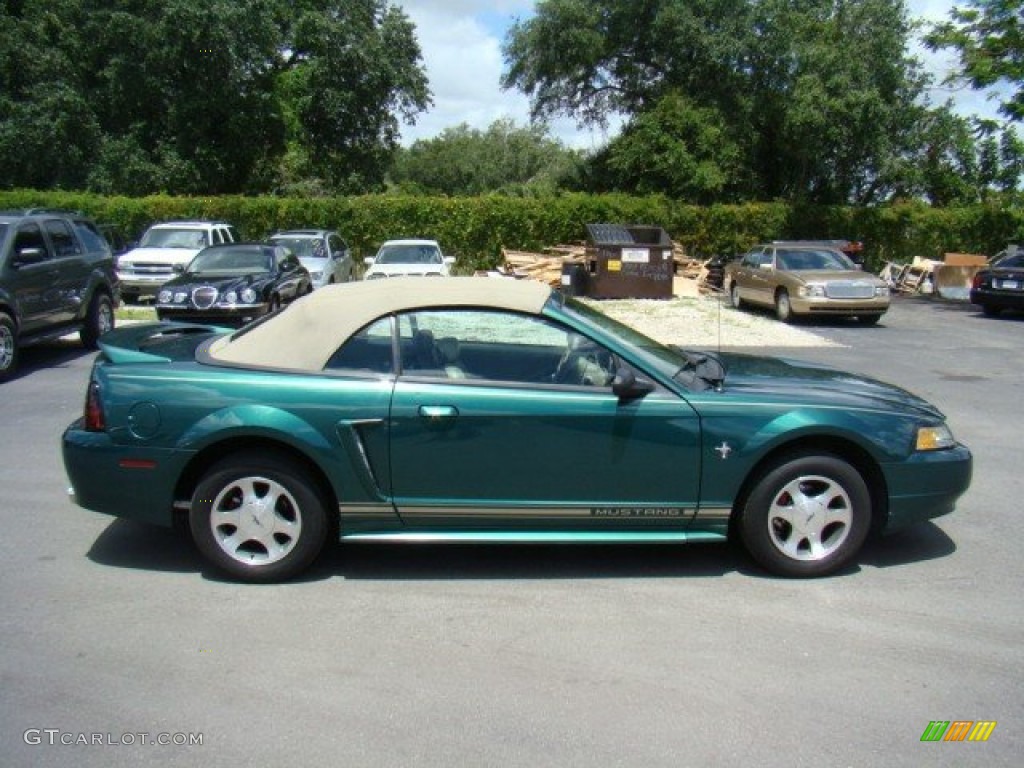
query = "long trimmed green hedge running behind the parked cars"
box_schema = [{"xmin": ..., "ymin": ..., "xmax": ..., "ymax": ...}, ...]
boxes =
[{"xmin": 0, "ymin": 189, "xmax": 1024, "ymax": 272}]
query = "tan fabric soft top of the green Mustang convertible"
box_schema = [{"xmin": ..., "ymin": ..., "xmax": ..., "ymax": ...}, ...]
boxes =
[{"xmin": 207, "ymin": 278, "xmax": 551, "ymax": 371}]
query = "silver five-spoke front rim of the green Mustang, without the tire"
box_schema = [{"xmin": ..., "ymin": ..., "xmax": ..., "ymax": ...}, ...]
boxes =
[{"xmin": 768, "ymin": 475, "xmax": 853, "ymax": 561}]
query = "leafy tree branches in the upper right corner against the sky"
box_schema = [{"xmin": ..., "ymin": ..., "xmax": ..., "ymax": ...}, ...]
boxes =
[{"xmin": 925, "ymin": 0, "xmax": 1024, "ymax": 121}]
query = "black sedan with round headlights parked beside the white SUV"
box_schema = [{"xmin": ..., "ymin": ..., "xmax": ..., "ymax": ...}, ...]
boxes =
[{"xmin": 157, "ymin": 243, "xmax": 312, "ymax": 326}]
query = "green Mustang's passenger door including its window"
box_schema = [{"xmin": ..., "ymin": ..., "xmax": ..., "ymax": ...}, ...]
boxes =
[{"xmin": 389, "ymin": 310, "xmax": 699, "ymax": 529}]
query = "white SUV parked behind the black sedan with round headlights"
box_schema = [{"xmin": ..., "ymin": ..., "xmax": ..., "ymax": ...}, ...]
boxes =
[{"xmin": 117, "ymin": 221, "xmax": 241, "ymax": 303}]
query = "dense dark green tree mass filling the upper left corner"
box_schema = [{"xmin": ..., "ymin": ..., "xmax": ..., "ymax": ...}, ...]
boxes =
[{"xmin": 0, "ymin": 0, "xmax": 429, "ymax": 195}]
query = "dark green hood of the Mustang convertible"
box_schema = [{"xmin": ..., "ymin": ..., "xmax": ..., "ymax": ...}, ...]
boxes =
[{"xmin": 719, "ymin": 353, "xmax": 943, "ymax": 420}]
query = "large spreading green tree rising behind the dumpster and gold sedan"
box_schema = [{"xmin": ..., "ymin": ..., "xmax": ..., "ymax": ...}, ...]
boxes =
[{"xmin": 502, "ymin": 0, "xmax": 927, "ymax": 203}]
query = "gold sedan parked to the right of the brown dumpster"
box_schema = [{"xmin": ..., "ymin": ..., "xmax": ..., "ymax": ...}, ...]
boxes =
[{"xmin": 724, "ymin": 243, "xmax": 889, "ymax": 326}]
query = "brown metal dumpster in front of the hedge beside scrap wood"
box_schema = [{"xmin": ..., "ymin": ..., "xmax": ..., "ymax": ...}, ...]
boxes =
[{"xmin": 586, "ymin": 224, "xmax": 675, "ymax": 299}]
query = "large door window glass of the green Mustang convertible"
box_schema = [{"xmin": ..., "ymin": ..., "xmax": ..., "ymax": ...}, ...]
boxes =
[{"xmin": 398, "ymin": 309, "xmax": 614, "ymax": 387}]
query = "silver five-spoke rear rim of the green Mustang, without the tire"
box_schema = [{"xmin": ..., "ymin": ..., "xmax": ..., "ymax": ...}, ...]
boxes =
[{"xmin": 210, "ymin": 477, "xmax": 302, "ymax": 565}]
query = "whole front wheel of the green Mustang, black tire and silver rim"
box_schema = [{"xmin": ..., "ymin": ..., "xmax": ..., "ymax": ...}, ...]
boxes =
[{"xmin": 739, "ymin": 455, "xmax": 871, "ymax": 578}]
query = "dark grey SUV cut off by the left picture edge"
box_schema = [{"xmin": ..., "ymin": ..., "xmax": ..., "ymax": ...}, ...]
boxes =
[{"xmin": 0, "ymin": 208, "xmax": 120, "ymax": 380}]
